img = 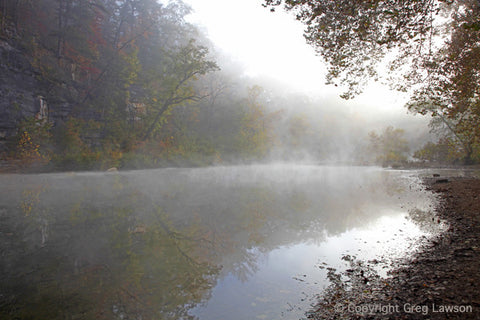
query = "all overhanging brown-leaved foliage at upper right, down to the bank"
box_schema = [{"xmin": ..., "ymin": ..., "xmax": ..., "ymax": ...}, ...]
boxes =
[{"xmin": 263, "ymin": 0, "xmax": 480, "ymax": 164}]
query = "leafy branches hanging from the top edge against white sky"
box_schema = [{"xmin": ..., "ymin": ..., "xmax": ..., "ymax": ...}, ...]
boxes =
[{"xmin": 264, "ymin": 0, "xmax": 451, "ymax": 98}]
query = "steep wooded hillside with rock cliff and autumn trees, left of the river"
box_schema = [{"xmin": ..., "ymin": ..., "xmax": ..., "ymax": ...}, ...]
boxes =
[{"xmin": 0, "ymin": 0, "xmax": 284, "ymax": 169}]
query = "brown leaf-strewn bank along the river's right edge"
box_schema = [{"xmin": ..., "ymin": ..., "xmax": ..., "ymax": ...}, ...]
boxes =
[{"xmin": 307, "ymin": 177, "xmax": 480, "ymax": 319}]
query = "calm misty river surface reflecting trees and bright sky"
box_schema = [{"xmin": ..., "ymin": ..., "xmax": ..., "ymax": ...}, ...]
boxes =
[{"xmin": 0, "ymin": 164, "xmax": 434, "ymax": 320}]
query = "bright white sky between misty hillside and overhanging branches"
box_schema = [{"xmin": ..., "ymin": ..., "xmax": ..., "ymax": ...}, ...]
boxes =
[{"xmin": 184, "ymin": 0, "xmax": 414, "ymax": 114}]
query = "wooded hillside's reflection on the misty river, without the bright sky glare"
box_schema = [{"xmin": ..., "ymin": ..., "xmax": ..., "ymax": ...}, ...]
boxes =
[{"xmin": 0, "ymin": 166, "xmax": 436, "ymax": 319}]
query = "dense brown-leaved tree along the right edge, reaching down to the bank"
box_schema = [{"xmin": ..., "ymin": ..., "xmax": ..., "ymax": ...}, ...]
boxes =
[{"xmin": 407, "ymin": 1, "xmax": 480, "ymax": 164}]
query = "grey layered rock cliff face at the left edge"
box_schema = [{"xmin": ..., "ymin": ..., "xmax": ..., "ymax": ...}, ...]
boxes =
[{"xmin": 0, "ymin": 39, "xmax": 72, "ymax": 153}]
